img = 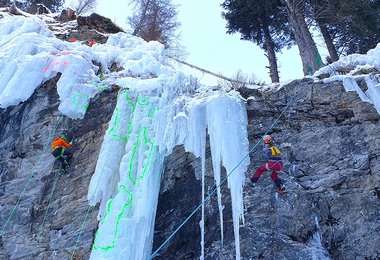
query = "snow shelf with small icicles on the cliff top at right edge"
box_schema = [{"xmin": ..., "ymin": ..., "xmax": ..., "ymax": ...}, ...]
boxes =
[{"xmin": 314, "ymin": 43, "xmax": 380, "ymax": 114}]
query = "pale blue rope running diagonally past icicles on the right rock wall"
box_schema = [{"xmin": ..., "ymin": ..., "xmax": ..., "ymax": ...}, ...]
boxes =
[{"xmin": 149, "ymin": 98, "xmax": 294, "ymax": 259}]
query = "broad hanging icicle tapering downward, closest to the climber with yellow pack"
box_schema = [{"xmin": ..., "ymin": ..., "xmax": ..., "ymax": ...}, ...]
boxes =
[{"xmin": 207, "ymin": 93, "xmax": 249, "ymax": 259}]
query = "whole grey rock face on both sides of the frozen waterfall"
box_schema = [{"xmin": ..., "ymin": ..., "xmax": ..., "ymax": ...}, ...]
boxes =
[{"xmin": 0, "ymin": 73, "xmax": 380, "ymax": 259}]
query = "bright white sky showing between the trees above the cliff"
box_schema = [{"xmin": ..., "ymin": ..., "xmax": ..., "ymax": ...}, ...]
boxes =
[{"xmin": 93, "ymin": 0, "xmax": 327, "ymax": 85}]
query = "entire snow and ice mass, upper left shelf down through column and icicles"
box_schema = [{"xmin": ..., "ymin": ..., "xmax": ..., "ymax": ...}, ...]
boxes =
[{"xmin": 0, "ymin": 16, "xmax": 249, "ymax": 259}]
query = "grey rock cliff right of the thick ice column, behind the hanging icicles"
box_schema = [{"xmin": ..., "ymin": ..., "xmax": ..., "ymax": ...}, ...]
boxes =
[{"xmin": 152, "ymin": 79, "xmax": 380, "ymax": 259}]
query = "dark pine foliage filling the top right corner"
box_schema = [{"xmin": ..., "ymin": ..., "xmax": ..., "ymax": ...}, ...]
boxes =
[{"xmin": 310, "ymin": 0, "xmax": 380, "ymax": 57}]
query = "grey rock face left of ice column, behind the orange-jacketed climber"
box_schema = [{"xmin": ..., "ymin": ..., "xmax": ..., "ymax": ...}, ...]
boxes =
[{"xmin": 0, "ymin": 76, "xmax": 116, "ymax": 259}]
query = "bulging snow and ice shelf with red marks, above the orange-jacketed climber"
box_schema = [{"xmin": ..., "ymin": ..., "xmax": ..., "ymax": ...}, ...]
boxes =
[{"xmin": 0, "ymin": 13, "xmax": 174, "ymax": 118}]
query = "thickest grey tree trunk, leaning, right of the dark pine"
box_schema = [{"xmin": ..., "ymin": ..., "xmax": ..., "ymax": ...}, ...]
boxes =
[{"xmin": 281, "ymin": 0, "xmax": 323, "ymax": 75}]
